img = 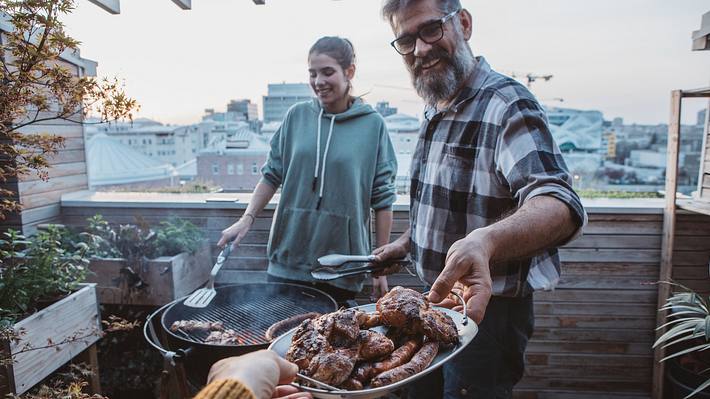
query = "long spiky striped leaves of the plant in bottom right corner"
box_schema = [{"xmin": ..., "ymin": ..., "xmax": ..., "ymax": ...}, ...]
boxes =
[{"xmin": 653, "ymin": 283, "xmax": 710, "ymax": 398}]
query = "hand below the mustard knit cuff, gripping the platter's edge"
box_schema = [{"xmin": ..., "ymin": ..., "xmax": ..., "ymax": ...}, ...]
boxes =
[{"xmin": 207, "ymin": 350, "xmax": 310, "ymax": 399}]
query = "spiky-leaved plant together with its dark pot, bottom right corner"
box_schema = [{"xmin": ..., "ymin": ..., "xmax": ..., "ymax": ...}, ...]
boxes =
[{"xmin": 653, "ymin": 283, "xmax": 710, "ymax": 398}]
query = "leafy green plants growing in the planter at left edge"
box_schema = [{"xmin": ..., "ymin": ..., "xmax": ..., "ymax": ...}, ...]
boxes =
[{"xmin": 0, "ymin": 226, "xmax": 89, "ymax": 325}]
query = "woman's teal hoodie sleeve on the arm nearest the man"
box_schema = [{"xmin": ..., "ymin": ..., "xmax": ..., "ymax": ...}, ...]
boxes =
[{"xmin": 370, "ymin": 123, "xmax": 397, "ymax": 211}]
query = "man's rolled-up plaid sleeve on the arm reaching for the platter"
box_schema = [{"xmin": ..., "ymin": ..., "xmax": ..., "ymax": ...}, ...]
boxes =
[{"xmin": 496, "ymin": 99, "xmax": 587, "ymax": 241}]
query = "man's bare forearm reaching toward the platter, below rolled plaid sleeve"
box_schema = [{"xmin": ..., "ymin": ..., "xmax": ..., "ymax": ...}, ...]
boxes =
[{"xmin": 469, "ymin": 195, "xmax": 578, "ymax": 264}]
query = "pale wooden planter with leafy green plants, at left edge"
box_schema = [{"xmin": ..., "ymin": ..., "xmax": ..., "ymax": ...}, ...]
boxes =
[{"xmin": 0, "ymin": 228, "xmax": 101, "ymax": 394}]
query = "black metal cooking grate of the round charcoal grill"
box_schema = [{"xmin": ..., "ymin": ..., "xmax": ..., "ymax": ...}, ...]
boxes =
[{"xmin": 165, "ymin": 297, "xmax": 324, "ymax": 345}]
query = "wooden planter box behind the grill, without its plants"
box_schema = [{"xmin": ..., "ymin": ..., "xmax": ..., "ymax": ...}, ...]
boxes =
[{"xmin": 87, "ymin": 242, "xmax": 212, "ymax": 306}]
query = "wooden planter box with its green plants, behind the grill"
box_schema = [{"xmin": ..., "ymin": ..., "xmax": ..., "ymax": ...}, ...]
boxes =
[{"xmin": 82, "ymin": 215, "xmax": 211, "ymax": 306}]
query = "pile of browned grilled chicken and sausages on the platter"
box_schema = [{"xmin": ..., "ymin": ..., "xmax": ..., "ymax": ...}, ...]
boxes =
[{"xmin": 286, "ymin": 287, "xmax": 458, "ymax": 390}]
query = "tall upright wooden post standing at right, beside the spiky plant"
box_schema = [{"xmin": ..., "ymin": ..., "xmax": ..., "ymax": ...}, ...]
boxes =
[{"xmin": 652, "ymin": 90, "xmax": 682, "ymax": 399}]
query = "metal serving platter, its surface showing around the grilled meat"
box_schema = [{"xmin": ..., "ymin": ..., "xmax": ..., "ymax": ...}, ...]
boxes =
[{"xmin": 269, "ymin": 303, "xmax": 478, "ymax": 399}]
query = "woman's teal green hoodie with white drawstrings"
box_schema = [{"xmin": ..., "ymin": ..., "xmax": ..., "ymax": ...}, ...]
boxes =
[{"xmin": 261, "ymin": 99, "xmax": 397, "ymax": 291}]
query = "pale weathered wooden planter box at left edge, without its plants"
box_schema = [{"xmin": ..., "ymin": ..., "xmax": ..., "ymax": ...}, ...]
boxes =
[{"xmin": 0, "ymin": 284, "xmax": 101, "ymax": 395}]
